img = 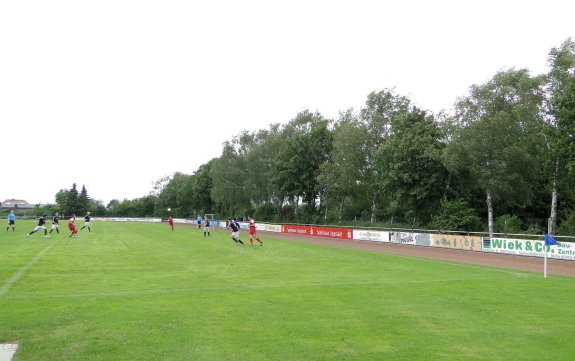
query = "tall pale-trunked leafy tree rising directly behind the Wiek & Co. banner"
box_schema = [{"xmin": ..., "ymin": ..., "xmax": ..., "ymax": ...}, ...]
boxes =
[{"xmin": 445, "ymin": 69, "xmax": 543, "ymax": 234}]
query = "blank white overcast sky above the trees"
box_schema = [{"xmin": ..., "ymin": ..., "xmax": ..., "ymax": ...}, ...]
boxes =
[{"xmin": 0, "ymin": 0, "xmax": 575, "ymax": 205}]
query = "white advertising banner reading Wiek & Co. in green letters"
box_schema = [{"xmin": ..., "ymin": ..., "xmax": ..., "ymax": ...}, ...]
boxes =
[{"xmin": 483, "ymin": 238, "xmax": 575, "ymax": 260}]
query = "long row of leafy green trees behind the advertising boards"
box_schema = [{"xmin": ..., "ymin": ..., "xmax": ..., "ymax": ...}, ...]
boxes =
[{"xmin": 41, "ymin": 39, "xmax": 575, "ymax": 234}]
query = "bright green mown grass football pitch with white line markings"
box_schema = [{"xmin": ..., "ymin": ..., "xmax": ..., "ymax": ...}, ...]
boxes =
[{"xmin": 0, "ymin": 221, "xmax": 575, "ymax": 361}]
